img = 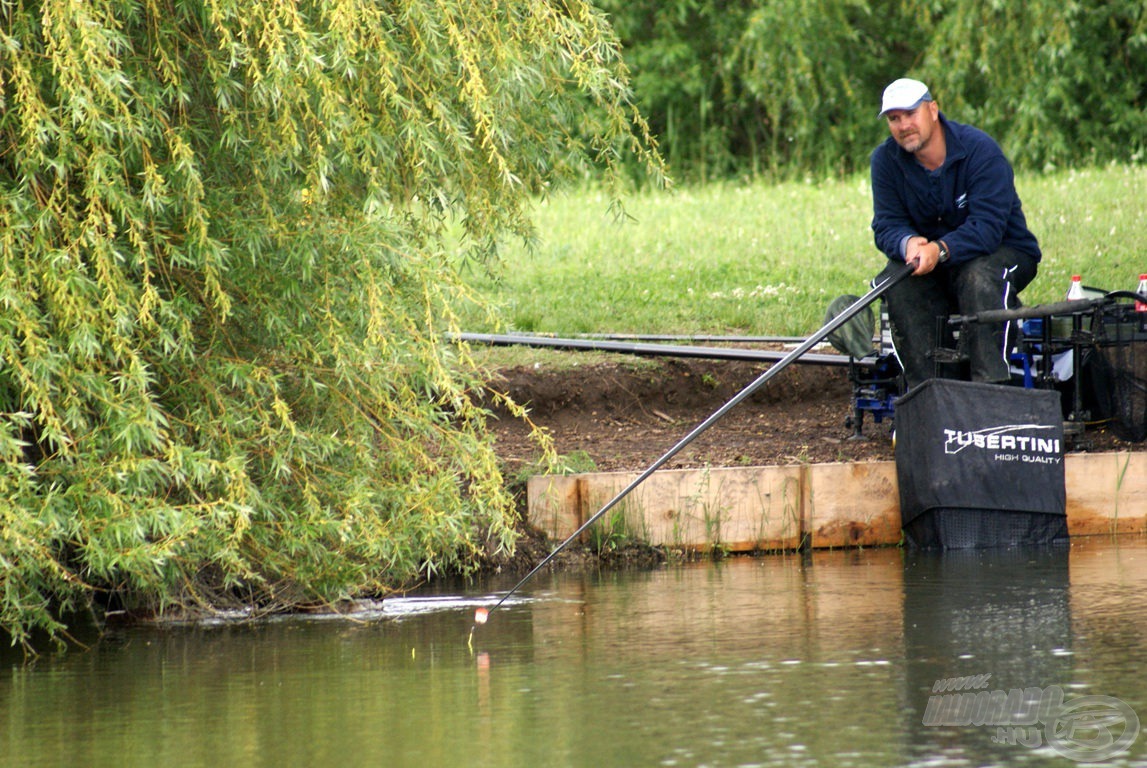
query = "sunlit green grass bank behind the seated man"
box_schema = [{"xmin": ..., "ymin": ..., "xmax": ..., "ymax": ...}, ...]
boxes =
[{"xmin": 465, "ymin": 166, "xmax": 1147, "ymax": 336}]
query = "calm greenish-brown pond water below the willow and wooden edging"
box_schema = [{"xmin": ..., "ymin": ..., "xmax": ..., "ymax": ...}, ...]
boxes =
[{"xmin": 0, "ymin": 540, "xmax": 1147, "ymax": 768}]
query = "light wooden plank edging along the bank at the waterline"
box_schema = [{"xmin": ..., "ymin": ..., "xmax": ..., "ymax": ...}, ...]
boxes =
[{"xmin": 526, "ymin": 452, "xmax": 1147, "ymax": 551}]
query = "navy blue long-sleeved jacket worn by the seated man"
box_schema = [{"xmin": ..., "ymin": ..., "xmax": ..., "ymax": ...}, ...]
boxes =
[{"xmin": 872, "ymin": 113, "xmax": 1040, "ymax": 264}]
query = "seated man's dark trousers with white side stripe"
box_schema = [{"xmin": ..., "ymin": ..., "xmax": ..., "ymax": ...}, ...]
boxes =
[{"xmin": 876, "ymin": 248, "xmax": 1038, "ymax": 387}]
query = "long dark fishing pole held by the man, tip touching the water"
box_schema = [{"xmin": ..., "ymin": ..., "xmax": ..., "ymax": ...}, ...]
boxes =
[{"xmin": 470, "ymin": 261, "xmax": 916, "ymax": 638}]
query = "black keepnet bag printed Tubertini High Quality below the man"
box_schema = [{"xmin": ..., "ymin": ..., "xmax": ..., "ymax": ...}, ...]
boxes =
[{"xmin": 896, "ymin": 378, "xmax": 1068, "ymax": 549}]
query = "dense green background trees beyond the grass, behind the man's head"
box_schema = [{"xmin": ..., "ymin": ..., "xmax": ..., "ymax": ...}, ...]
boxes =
[{"xmin": 598, "ymin": 0, "xmax": 1147, "ymax": 180}]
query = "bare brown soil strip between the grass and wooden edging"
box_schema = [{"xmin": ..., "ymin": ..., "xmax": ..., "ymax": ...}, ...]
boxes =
[{"xmin": 481, "ymin": 358, "xmax": 1147, "ymax": 477}]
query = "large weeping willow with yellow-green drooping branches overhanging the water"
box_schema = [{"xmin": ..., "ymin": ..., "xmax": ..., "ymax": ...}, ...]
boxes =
[{"xmin": 0, "ymin": 0, "xmax": 658, "ymax": 642}]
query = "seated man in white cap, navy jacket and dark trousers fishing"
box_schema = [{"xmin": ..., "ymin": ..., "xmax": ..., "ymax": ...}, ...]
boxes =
[{"xmin": 872, "ymin": 78, "xmax": 1040, "ymax": 387}]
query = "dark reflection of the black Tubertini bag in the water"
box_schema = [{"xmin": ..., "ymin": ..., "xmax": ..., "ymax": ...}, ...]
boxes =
[{"xmin": 904, "ymin": 546, "xmax": 1072, "ymax": 763}]
